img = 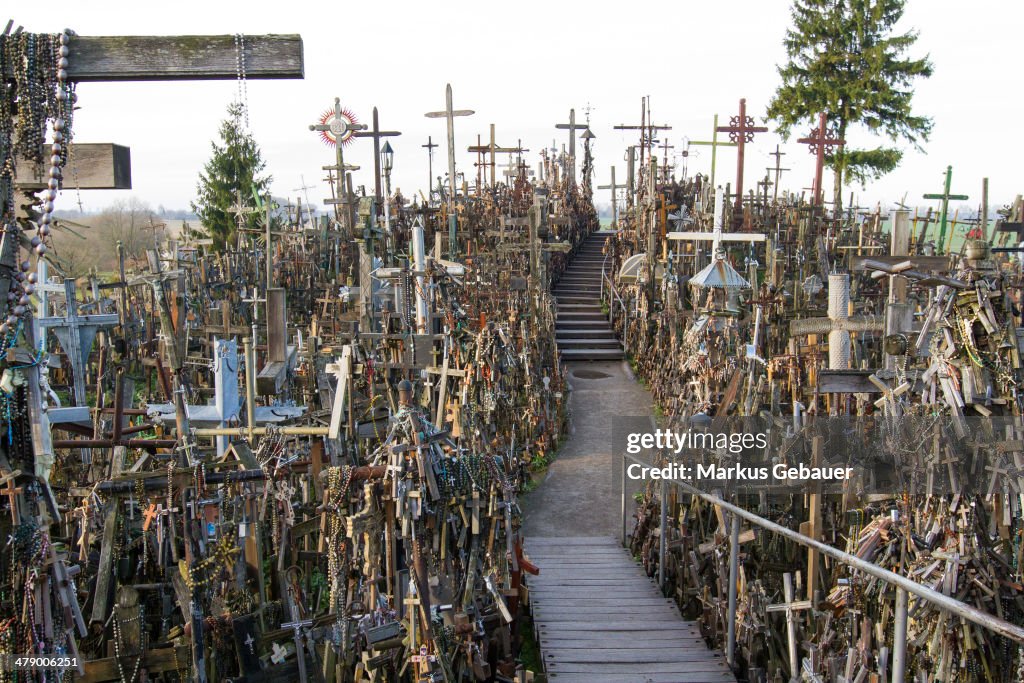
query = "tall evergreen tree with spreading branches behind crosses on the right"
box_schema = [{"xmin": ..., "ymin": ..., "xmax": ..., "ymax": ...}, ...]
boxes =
[{"xmin": 768, "ymin": 0, "xmax": 932, "ymax": 209}]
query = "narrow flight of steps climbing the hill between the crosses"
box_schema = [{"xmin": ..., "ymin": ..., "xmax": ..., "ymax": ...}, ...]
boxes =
[{"xmin": 553, "ymin": 232, "xmax": 625, "ymax": 360}]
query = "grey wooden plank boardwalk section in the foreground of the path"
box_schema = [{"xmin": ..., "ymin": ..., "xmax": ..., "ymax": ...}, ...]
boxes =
[{"xmin": 526, "ymin": 537, "xmax": 736, "ymax": 683}]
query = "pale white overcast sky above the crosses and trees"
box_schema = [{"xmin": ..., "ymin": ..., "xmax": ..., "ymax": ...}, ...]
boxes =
[{"xmin": 18, "ymin": 0, "xmax": 1024, "ymax": 216}]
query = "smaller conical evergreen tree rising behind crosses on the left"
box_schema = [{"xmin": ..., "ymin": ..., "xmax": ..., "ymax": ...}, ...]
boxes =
[{"xmin": 191, "ymin": 102, "xmax": 271, "ymax": 251}]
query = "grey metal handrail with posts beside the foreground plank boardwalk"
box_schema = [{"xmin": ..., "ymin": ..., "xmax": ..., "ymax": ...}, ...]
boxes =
[{"xmin": 622, "ymin": 453, "xmax": 1024, "ymax": 683}]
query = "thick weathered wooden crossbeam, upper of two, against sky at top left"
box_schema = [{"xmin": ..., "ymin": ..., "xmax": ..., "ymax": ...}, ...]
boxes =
[{"xmin": 3, "ymin": 34, "xmax": 304, "ymax": 83}]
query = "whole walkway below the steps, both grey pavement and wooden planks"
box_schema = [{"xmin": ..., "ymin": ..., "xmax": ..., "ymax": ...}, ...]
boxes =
[{"xmin": 523, "ymin": 362, "xmax": 735, "ymax": 683}]
